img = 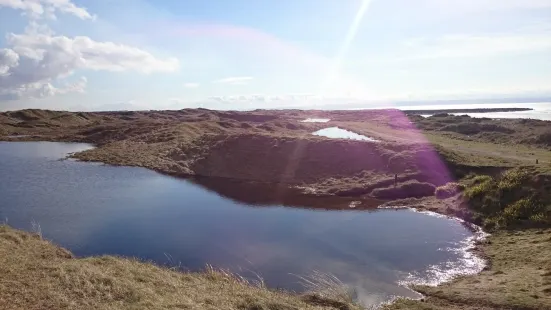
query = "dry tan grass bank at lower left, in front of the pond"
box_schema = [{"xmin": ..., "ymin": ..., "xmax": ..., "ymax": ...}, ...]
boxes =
[{"xmin": 0, "ymin": 226, "xmax": 355, "ymax": 310}]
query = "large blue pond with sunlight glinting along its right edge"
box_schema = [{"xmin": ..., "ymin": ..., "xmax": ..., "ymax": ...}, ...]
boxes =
[{"xmin": 0, "ymin": 142, "xmax": 482, "ymax": 304}]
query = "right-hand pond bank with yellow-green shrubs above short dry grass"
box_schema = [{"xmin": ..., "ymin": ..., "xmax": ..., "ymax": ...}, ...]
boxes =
[{"xmin": 385, "ymin": 168, "xmax": 551, "ymax": 310}]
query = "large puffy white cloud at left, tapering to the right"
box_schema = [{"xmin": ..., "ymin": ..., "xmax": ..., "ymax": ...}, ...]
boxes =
[{"xmin": 0, "ymin": 26, "xmax": 179, "ymax": 99}]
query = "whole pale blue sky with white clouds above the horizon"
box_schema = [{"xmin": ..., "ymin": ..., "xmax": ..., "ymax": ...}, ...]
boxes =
[{"xmin": 0, "ymin": 0, "xmax": 551, "ymax": 111}]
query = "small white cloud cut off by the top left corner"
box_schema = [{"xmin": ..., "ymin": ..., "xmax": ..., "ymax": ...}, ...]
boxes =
[{"xmin": 0, "ymin": 0, "xmax": 96, "ymax": 20}]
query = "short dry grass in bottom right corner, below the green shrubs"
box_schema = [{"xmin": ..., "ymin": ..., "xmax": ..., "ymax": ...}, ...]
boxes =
[{"xmin": 385, "ymin": 229, "xmax": 551, "ymax": 310}]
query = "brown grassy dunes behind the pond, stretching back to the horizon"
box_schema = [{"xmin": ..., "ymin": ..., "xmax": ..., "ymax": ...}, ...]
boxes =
[{"xmin": 0, "ymin": 109, "xmax": 551, "ymax": 196}]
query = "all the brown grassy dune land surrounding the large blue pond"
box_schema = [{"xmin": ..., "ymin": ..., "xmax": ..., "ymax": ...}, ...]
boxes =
[{"xmin": 0, "ymin": 109, "xmax": 551, "ymax": 310}]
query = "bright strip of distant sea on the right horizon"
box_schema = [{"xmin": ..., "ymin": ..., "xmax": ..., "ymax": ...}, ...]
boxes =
[{"xmin": 402, "ymin": 102, "xmax": 551, "ymax": 121}]
